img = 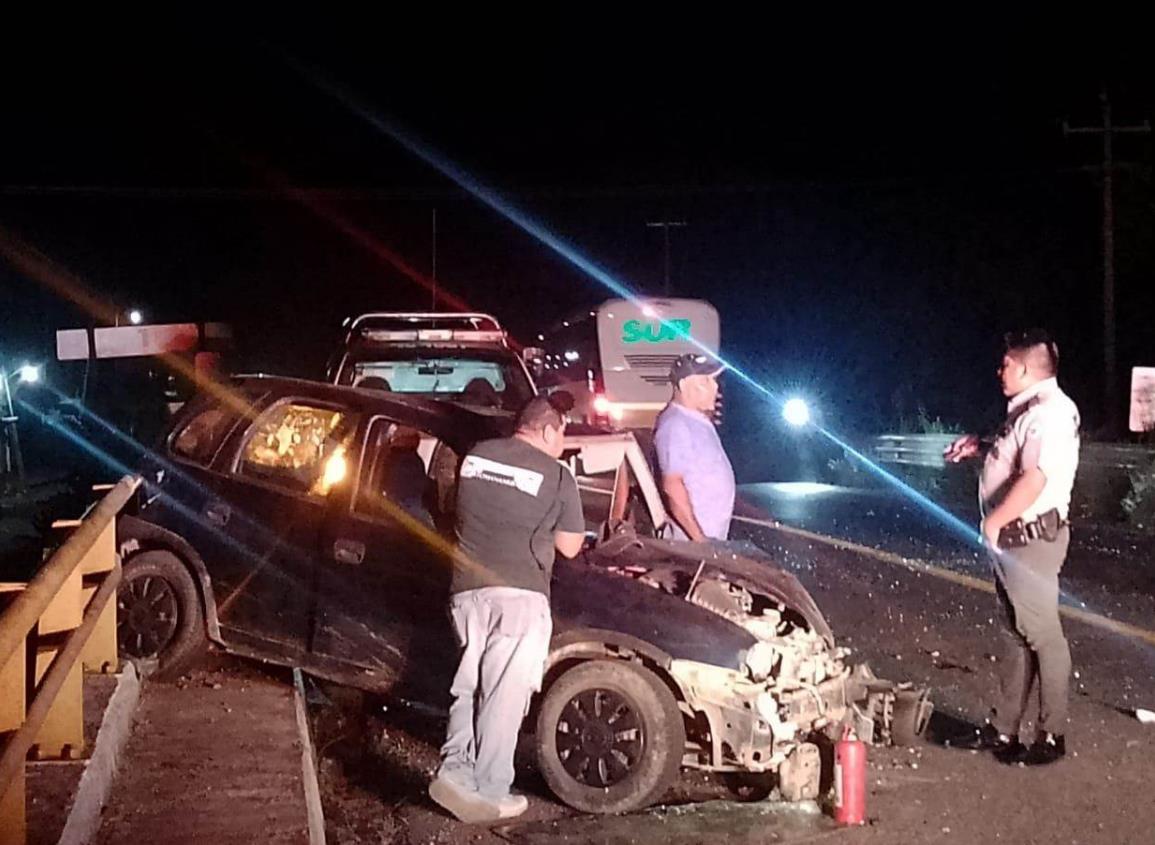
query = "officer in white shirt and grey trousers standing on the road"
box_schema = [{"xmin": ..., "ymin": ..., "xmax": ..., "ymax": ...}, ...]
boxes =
[{"xmin": 945, "ymin": 329, "xmax": 1079, "ymax": 765}]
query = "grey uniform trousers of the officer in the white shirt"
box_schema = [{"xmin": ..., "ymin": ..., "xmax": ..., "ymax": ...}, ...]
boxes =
[{"xmin": 991, "ymin": 528, "xmax": 1071, "ymax": 736}]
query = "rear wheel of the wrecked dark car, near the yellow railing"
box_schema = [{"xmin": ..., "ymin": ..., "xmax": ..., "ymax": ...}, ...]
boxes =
[{"xmin": 117, "ymin": 551, "xmax": 208, "ymax": 680}]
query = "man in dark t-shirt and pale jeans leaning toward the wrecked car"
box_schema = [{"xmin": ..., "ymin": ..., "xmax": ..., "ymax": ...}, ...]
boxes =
[{"xmin": 430, "ymin": 396, "xmax": 586, "ymax": 822}]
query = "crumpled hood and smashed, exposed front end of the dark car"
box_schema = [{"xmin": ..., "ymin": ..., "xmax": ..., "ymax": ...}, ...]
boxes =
[{"xmin": 590, "ymin": 531, "xmax": 932, "ymax": 800}]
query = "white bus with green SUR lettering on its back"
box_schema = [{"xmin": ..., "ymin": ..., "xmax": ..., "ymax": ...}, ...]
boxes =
[{"xmin": 537, "ymin": 299, "xmax": 721, "ymax": 428}]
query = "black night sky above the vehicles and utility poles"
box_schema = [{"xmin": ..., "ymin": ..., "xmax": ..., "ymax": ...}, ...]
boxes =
[{"xmin": 0, "ymin": 24, "xmax": 1155, "ymax": 475}]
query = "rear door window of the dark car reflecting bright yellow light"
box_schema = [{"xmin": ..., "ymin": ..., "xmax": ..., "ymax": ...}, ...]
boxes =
[{"xmin": 238, "ymin": 402, "xmax": 357, "ymax": 496}]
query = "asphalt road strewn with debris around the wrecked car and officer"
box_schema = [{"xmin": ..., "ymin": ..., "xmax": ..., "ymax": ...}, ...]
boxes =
[{"xmin": 315, "ymin": 485, "xmax": 1155, "ymax": 845}]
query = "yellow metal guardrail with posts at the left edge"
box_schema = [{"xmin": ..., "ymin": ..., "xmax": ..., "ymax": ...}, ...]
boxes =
[{"xmin": 0, "ymin": 477, "xmax": 140, "ymax": 845}]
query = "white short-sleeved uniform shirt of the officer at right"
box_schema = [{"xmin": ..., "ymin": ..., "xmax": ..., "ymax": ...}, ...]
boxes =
[{"xmin": 978, "ymin": 379, "xmax": 1079, "ymax": 522}]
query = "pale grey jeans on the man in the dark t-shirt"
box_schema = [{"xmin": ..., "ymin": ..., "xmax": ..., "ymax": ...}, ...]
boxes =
[{"xmin": 438, "ymin": 586, "xmax": 553, "ymax": 800}]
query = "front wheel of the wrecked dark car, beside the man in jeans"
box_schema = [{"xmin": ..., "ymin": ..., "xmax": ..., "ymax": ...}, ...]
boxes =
[{"xmin": 536, "ymin": 660, "xmax": 686, "ymax": 813}]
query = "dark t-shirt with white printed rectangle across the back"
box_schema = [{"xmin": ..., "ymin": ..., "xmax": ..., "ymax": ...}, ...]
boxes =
[{"xmin": 452, "ymin": 438, "xmax": 586, "ymax": 596}]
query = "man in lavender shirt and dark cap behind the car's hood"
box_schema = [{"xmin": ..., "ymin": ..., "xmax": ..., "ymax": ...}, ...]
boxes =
[{"xmin": 654, "ymin": 353, "xmax": 735, "ymax": 543}]
